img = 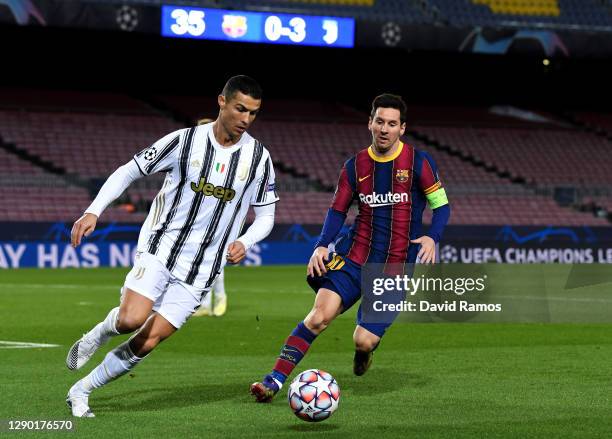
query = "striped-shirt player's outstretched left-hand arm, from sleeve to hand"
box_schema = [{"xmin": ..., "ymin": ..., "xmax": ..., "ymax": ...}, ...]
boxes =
[{"xmin": 70, "ymin": 130, "xmax": 185, "ymax": 247}]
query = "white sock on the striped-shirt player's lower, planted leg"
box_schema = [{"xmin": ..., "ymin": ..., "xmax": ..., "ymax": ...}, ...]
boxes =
[{"xmin": 81, "ymin": 340, "xmax": 142, "ymax": 394}]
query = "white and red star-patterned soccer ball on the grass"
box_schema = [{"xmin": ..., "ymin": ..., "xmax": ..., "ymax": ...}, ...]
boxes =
[{"xmin": 287, "ymin": 369, "xmax": 340, "ymax": 422}]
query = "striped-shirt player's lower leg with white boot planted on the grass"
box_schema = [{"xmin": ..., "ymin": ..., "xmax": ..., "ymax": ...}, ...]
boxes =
[{"xmin": 66, "ymin": 313, "xmax": 176, "ymax": 417}]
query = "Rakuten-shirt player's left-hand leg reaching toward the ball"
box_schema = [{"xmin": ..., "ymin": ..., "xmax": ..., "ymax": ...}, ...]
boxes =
[{"xmin": 251, "ymin": 288, "xmax": 343, "ymax": 402}]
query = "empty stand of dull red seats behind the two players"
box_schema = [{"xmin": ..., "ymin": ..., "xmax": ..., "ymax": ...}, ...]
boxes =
[{"xmin": 0, "ymin": 92, "xmax": 612, "ymax": 225}]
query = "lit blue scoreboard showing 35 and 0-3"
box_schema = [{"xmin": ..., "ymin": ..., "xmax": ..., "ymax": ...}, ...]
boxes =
[{"xmin": 161, "ymin": 5, "xmax": 355, "ymax": 47}]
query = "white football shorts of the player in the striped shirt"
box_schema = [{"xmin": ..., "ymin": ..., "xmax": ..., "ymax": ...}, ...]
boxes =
[{"xmin": 121, "ymin": 252, "xmax": 208, "ymax": 329}]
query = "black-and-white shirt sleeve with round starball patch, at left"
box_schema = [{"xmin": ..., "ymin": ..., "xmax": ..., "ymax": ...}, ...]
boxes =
[{"xmin": 134, "ymin": 129, "xmax": 186, "ymax": 175}]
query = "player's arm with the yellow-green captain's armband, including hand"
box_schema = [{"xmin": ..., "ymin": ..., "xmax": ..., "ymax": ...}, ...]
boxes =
[{"xmin": 411, "ymin": 154, "xmax": 450, "ymax": 264}]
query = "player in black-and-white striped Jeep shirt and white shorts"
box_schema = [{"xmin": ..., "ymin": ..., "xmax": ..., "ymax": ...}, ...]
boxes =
[{"xmin": 66, "ymin": 76, "xmax": 278, "ymax": 417}]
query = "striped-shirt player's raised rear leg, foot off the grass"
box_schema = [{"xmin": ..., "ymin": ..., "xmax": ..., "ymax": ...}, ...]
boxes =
[{"xmin": 66, "ymin": 287, "xmax": 153, "ymax": 370}]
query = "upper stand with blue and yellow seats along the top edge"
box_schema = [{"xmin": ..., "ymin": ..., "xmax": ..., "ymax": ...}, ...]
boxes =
[{"xmin": 98, "ymin": 0, "xmax": 612, "ymax": 30}]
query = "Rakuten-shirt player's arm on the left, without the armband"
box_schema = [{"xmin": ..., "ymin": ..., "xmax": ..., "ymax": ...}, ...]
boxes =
[{"xmin": 306, "ymin": 162, "xmax": 355, "ymax": 276}]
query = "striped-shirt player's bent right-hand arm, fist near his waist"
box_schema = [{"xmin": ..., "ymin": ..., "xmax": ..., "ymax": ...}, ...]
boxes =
[{"xmin": 227, "ymin": 151, "xmax": 279, "ymax": 264}]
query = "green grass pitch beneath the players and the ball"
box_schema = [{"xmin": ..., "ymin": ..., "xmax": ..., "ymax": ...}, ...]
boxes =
[{"xmin": 0, "ymin": 267, "xmax": 612, "ymax": 439}]
